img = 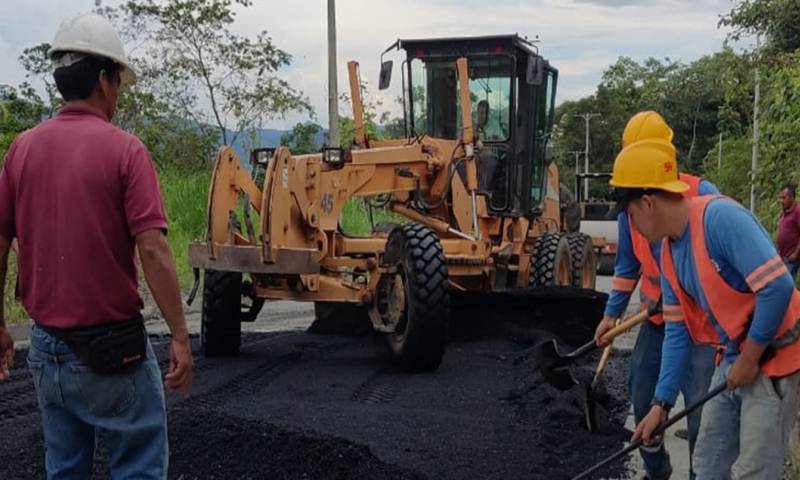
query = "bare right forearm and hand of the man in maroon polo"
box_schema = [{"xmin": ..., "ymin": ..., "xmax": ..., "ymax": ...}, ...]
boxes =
[{"xmin": 136, "ymin": 229, "xmax": 192, "ymax": 393}]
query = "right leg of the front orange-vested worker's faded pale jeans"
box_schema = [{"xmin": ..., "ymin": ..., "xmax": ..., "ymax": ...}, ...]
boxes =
[{"xmin": 733, "ymin": 373, "xmax": 800, "ymax": 480}]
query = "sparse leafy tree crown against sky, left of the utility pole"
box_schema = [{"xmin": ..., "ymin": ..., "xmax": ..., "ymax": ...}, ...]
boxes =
[{"xmin": 116, "ymin": 0, "xmax": 313, "ymax": 144}]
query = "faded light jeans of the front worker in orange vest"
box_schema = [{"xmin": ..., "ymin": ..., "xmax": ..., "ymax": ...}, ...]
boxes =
[{"xmin": 694, "ymin": 358, "xmax": 800, "ymax": 480}]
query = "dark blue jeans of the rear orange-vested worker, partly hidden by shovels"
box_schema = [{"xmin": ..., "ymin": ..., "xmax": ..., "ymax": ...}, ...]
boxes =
[{"xmin": 628, "ymin": 322, "xmax": 715, "ymax": 480}]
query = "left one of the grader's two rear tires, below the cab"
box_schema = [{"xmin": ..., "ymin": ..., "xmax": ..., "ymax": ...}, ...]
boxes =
[{"xmin": 528, "ymin": 233, "xmax": 572, "ymax": 287}]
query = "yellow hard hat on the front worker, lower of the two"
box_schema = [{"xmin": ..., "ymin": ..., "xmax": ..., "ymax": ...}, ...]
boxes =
[{"xmin": 609, "ymin": 138, "xmax": 689, "ymax": 193}]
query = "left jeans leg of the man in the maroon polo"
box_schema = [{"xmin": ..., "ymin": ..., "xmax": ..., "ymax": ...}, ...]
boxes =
[{"xmin": 28, "ymin": 327, "xmax": 94, "ymax": 480}]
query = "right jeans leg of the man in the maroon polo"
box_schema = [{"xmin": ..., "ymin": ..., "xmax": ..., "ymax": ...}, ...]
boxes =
[{"xmin": 96, "ymin": 342, "xmax": 168, "ymax": 479}]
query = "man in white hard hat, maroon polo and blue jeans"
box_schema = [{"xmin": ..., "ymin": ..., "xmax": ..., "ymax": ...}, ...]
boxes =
[{"xmin": 0, "ymin": 14, "xmax": 192, "ymax": 479}]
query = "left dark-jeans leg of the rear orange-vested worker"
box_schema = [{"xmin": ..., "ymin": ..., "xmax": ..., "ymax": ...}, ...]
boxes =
[{"xmin": 628, "ymin": 322, "xmax": 672, "ymax": 480}]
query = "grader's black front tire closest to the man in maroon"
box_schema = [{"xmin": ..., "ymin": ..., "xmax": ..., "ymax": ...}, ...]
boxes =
[{"xmin": 200, "ymin": 270, "xmax": 242, "ymax": 357}]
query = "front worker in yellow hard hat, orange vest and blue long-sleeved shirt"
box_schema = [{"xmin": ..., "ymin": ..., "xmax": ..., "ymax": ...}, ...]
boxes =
[{"xmin": 611, "ymin": 139, "xmax": 800, "ymax": 480}]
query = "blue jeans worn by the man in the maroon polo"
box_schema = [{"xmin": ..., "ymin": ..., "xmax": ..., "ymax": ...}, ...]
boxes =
[{"xmin": 28, "ymin": 326, "xmax": 168, "ymax": 479}]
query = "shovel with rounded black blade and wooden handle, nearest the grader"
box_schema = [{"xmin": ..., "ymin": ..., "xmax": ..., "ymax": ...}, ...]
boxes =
[{"xmin": 533, "ymin": 310, "xmax": 650, "ymax": 390}]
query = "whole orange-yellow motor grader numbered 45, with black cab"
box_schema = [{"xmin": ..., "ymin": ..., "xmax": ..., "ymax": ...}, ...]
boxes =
[{"xmin": 189, "ymin": 35, "xmax": 595, "ymax": 371}]
